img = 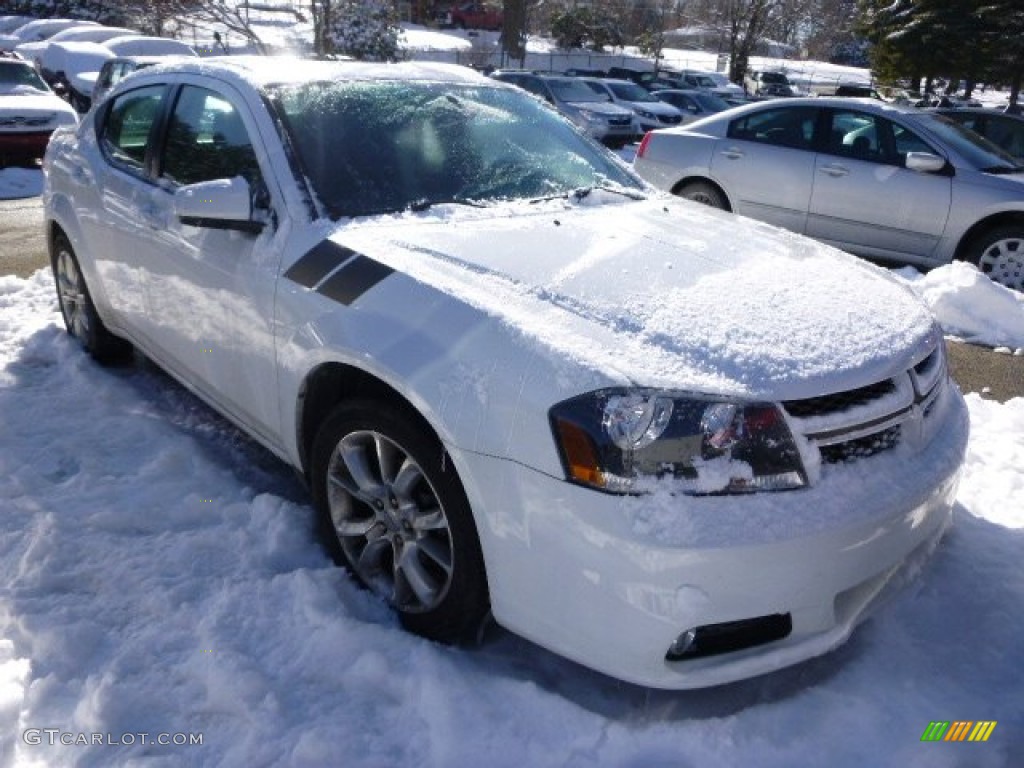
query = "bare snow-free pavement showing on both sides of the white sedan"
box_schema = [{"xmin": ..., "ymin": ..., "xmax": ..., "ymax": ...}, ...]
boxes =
[{"xmin": 0, "ymin": 189, "xmax": 1024, "ymax": 402}]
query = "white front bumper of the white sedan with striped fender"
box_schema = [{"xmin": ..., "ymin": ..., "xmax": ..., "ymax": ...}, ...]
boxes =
[{"xmin": 459, "ymin": 387, "xmax": 968, "ymax": 688}]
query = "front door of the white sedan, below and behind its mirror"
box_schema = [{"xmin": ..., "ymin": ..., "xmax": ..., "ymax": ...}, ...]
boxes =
[{"xmin": 136, "ymin": 79, "xmax": 284, "ymax": 442}]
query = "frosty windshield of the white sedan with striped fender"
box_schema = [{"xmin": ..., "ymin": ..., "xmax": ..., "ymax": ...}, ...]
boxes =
[{"xmin": 270, "ymin": 81, "xmax": 644, "ymax": 218}]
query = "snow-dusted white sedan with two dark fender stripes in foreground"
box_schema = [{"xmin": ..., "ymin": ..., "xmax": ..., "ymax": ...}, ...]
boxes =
[{"xmin": 43, "ymin": 56, "xmax": 968, "ymax": 688}]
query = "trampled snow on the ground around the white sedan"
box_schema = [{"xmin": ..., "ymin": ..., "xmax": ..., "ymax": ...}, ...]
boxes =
[{"xmin": 0, "ymin": 270, "xmax": 1024, "ymax": 768}]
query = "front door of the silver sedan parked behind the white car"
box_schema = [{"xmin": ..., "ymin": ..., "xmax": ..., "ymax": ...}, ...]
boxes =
[{"xmin": 807, "ymin": 109, "xmax": 952, "ymax": 259}]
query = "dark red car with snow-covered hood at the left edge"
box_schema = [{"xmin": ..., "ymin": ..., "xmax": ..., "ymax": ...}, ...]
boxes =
[{"xmin": 0, "ymin": 57, "xmax": 78, "ymax": 168}]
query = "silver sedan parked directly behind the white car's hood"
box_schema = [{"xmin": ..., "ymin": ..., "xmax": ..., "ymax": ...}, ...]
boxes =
[{"xmin": 634, "ymin": 97, "xmax": 1024, "ymax": 291}]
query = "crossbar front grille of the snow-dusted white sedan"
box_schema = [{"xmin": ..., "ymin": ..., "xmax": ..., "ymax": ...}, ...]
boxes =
[{"xmin": 782, "ymin": 342, "xmax": 946, "ymax": 464}]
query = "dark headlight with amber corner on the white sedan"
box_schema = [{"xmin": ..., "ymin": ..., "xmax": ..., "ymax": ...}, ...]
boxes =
[{"xmin": 550, "ymin": 389, "xmax": 807, "ymax": 494}]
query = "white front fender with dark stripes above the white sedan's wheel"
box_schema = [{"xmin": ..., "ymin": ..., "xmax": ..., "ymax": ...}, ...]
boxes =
[{"xmin": 278, "ymin": 243, "xmax": 625, "ymax": 477}]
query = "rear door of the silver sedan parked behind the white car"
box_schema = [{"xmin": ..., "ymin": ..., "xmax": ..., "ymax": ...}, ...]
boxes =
[{"xmin": 711, "ymin": 105, "xmax": 819, "ymax": 232}]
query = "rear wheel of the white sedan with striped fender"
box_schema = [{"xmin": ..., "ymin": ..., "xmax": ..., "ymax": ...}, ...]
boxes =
[{"xmin": 50, "ymin": 232, "xmax": 131, "ymax": 364}]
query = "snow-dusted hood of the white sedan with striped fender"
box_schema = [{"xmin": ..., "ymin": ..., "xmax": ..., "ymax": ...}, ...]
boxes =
[{"xmin": 331, "ymin": 193, "xmax": 940, "ymax": 399}]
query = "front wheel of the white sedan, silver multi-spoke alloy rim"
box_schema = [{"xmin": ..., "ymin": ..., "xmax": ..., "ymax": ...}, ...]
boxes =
[{"xmin": 311, "ymin": 400, "xmax": 489, "ymax": 642}]
